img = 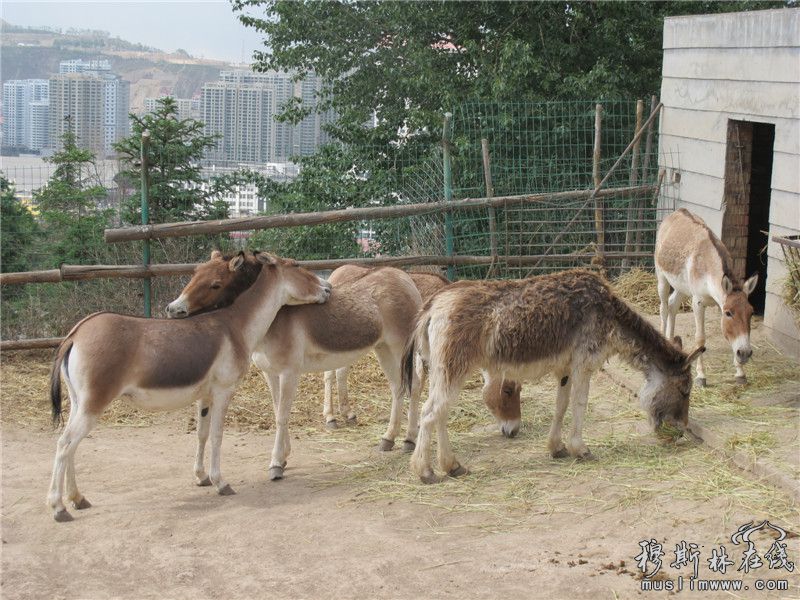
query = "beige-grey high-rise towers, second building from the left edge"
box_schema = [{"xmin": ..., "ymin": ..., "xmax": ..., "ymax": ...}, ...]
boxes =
[{"xmin": 49, "ymin": 61, "xmax": 130, "ymax": 157}]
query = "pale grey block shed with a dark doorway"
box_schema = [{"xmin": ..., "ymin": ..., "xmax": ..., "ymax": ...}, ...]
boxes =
[{"xmin": 659, "ymin": 9, "xmax": 800, "ymax": 357}]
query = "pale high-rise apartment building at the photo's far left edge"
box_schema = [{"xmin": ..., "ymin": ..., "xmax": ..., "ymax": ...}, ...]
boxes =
[{"xmin": 3, "ymin": 79, "xmax": 49, "ymax": 151}]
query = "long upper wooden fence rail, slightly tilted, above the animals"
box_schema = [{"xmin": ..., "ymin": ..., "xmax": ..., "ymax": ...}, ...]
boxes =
[{"xmin": 105, "ymin": 186, "xmax": 653, "ymax": 244}]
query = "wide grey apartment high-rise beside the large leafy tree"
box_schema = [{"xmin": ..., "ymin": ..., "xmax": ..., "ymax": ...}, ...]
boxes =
[{"xmin": 201, "ymin": 71, "xmax": 334, "ymax": 164}]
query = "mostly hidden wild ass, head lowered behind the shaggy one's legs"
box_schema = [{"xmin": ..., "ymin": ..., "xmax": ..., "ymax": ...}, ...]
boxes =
[{"xmin": 323, "ymin": 265, "xmax": 522, "ymax": 440}]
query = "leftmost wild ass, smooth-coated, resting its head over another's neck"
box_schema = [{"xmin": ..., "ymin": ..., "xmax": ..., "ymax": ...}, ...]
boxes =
[{"xmin": 47, "ymin": 254, "xmax": 330, "ymax": 521}]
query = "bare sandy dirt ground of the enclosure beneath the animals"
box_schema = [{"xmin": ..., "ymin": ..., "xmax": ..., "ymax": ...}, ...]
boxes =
[{"xmin": 0, "ymin": 315, "xmax": 800, "ymax": 600}]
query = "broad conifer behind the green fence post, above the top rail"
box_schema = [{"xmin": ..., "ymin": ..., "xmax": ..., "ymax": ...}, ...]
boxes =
[{"xmin": 114, "ymin": 97, "xmax": 240, "ymax": 224}]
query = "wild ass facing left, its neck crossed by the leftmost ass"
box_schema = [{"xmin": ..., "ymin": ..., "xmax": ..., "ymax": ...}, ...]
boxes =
[{"xmin": 167, "ymin": 257, "xmax": 422, "ymax": 480}]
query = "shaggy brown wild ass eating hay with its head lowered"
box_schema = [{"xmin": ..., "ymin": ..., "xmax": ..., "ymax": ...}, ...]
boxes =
[{"xmin": 404, "ymin": 270, "xmax": 704, "ymax": 483}]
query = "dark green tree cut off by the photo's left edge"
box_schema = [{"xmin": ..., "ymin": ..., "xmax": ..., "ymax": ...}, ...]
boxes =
[{"xmin": 0, "ymin": 175, "xmax": 41, "ymax": 273}]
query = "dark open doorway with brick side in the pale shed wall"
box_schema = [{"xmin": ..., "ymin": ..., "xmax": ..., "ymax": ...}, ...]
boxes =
[{"xmin": 722, "ymin": 120, "xmax": 775, "ymax": 314}]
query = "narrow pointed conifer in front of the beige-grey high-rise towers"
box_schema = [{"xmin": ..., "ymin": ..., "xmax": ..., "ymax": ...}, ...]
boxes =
[{"xmin": 34, "ymin": 127, "xmax": 113, "ymax": 266}]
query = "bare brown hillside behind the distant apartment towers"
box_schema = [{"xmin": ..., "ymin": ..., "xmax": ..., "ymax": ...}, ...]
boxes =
[{"xmin": 0, "ymin": 22, "xmax": 239, "ymax": 112}]
